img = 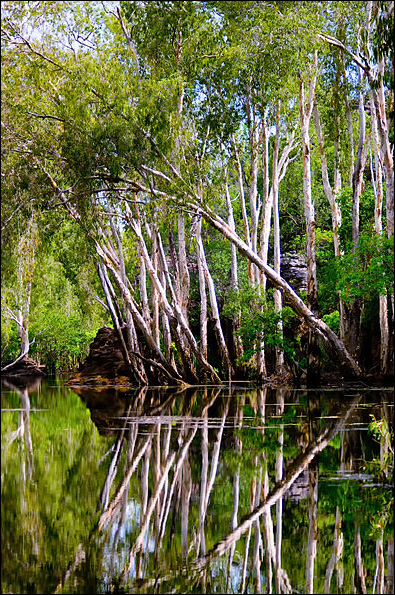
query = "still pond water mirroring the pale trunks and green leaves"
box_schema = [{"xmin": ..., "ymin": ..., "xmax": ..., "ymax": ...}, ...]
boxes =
[{"xmin": 1, "ymin": 378, "xmax": 394, "ymax": 594}]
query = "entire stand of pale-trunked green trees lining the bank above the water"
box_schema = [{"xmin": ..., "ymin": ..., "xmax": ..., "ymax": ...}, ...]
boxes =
[{"xmin": 2, "ymin": 1, "xmax": 394, "ymax": 384}]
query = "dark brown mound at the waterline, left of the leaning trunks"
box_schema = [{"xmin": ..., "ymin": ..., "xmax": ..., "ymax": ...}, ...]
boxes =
[{"xmin": 67, "ymin": 326, "xmax": 131, "ymax": 386}]
